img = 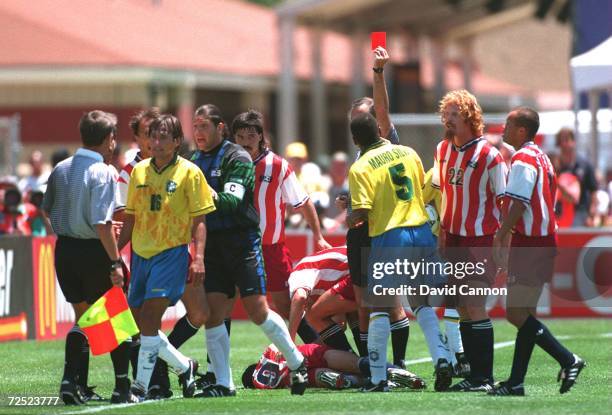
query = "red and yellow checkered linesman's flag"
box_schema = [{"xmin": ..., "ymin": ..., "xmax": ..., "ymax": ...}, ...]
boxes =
[{"xmin": 78, "ymin": 287, "xmax": 138, "ymax": 355}]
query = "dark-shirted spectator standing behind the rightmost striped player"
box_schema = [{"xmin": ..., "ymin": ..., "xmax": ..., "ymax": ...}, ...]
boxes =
[{"xmin": 556, "ymin": 128, "xmax": 597, "ymax": 226}]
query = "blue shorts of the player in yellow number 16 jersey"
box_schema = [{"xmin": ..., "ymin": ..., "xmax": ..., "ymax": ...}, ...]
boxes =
[{"xmin": 128, "ymin": 245, "xmax": 189, "ymax": 307}]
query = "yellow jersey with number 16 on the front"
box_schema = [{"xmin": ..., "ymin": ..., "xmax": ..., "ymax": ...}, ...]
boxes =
[{"xmin": 125, "ymin": 155, "xmax": 215, "ymax": 259}]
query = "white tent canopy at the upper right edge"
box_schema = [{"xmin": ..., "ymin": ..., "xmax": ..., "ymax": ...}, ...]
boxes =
[{"xmin": 570, "ymin": 36, "xmax": 612, "ymax": 92}]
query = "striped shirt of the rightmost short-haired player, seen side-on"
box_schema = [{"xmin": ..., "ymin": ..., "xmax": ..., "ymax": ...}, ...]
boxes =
[{"xmin": 506, "ymin": 141, "xmax": 557, "ymax": 236}]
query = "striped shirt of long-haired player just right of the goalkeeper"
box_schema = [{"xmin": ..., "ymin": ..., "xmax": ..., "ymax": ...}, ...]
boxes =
[{"xmin": 253, "ymin": 150, "xmax": 308, "ymax": 245}]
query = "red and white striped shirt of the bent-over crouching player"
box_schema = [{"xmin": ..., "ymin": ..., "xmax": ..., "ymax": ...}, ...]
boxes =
[{"xmin": 288, "ymin": 246, "xmax": 349, "ymax": 297}]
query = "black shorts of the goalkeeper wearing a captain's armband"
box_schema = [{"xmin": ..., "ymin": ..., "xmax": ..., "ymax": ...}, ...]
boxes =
[{"xmin": 204, "ymin": 229, "xmax": 266, "ymax": 298}]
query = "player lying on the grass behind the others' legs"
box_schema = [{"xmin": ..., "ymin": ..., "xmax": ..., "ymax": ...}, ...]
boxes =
[{"xmin": 242, "ymin": 344, "xmax": 425, "ymax": 389}]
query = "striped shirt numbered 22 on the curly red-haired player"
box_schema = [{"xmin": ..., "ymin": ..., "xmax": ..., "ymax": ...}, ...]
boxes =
[{"xmin": 432, "ymin": 137, "xmax": 507, "ymax": 236}]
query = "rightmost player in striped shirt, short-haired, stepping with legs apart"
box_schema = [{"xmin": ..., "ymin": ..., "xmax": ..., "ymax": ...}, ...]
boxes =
[{"xmin": 489, "ymin": 107, "xmax": 586, "ymax": 396}]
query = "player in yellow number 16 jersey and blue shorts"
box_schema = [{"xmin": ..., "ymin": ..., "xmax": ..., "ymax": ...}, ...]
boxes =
[{"xmin": 119, "ymin": 115, "xmax": 215, "ymax": 399}]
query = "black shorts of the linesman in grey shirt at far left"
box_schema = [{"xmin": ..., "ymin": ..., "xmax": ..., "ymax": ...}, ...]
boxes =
[{"xmin": 55, "ymin": 236, "xmax": 113, "ymax": 304}]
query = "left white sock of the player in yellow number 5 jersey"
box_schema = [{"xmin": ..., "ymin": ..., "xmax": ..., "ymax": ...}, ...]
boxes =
[{"xmin": 368, "ymin": 313, "xmax": 391, "ymax": 385}]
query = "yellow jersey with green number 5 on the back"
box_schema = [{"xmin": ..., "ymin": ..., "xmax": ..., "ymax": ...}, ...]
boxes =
[{"xmin": 349, "ymin": 142, "xmax": 428, "ymax": 237}]
